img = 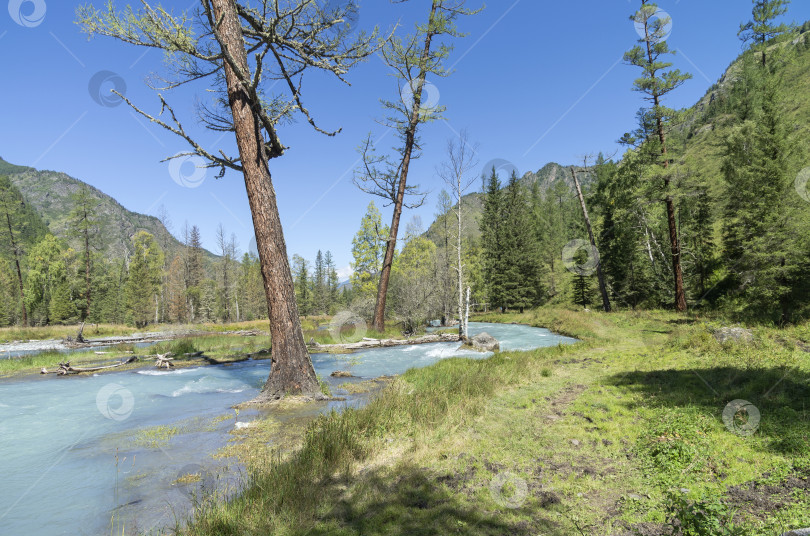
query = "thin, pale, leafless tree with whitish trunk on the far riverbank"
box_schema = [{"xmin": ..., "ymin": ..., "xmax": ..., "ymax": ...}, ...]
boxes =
[{"xmin": 438, "ymin": 130, "xmax": 478, "ymax": 338}]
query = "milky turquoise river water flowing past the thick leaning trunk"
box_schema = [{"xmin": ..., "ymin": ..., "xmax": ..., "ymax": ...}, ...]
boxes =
[{"xmin": 0, "ymin": 323, "xmax": 575, "ymax": 536}]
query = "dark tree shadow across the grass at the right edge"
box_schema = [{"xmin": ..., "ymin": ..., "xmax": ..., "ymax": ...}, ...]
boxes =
[{"xmin": 607, "ymin": 367, "xmax": 810, "ymax": 456}]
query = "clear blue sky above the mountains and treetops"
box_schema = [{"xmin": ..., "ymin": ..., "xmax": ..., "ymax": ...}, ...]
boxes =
[{"xmin": 0, "ymin": 0, "xmax": 810, "ymax": 276}]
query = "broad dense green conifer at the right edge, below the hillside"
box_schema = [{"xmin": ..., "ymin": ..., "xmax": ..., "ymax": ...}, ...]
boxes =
[{"xmin": 723, "ymin": 76, "xmax": 807, "ymax": 322}]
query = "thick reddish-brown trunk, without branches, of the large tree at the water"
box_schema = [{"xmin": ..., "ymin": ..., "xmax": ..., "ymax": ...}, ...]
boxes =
[{"xmin": 211, "ymin": 0, "xmax": 320, "ymax": 400}]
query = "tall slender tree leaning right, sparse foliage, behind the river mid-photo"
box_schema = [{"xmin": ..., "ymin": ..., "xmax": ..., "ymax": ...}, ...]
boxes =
[{"xmin": 355, "ymin": 0, "xmax": 480, "ymax": 332}]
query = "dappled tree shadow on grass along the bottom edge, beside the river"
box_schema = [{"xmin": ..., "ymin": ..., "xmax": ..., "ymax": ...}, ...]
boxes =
[{"xmin": 306, "ymin": 465, "xmax": 554, "ymax": 536}]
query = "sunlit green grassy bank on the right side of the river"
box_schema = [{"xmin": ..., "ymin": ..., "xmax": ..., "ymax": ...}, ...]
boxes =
[{"xmin": 178, "ymin": 310, "xmax": 810, "ymax": 536}]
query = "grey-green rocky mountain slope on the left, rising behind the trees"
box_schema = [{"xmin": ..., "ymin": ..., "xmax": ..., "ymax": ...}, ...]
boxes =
[{"xmin": 0, "ymin": 158, "xmax": 214, "ymax": 258}]
